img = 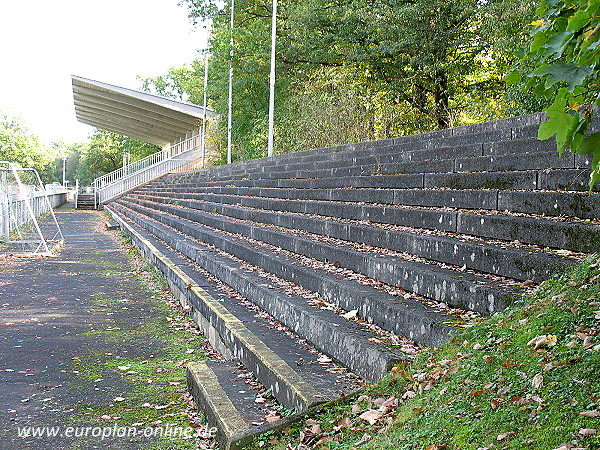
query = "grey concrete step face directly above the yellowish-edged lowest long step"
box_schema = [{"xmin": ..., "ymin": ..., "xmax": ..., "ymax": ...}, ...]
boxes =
[{"xmin": 113, "ymin": 204, "xmax": 405, "ymax": 381}]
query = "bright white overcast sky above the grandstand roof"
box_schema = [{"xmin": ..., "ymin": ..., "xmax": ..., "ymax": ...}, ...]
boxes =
[{"xmin": 0, "ymin": 0, "xmax": 207, "ymax": 143}]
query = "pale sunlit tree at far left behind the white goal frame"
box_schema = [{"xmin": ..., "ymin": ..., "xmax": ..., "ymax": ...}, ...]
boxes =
[{"xmin": 0, "ymin": 111, "xmax": 57, "ymax": 183}]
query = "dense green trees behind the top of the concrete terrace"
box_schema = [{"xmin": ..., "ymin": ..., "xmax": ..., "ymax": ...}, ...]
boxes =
[{"xmin": 175, "ymin": 0, "xmax": 533, "ymax": 162}]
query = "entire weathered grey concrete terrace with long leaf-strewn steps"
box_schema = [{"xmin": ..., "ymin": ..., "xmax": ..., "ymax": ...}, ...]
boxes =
[{"xmin": 107, "ymin": 114, "xmax": 600, "ymax": 448}]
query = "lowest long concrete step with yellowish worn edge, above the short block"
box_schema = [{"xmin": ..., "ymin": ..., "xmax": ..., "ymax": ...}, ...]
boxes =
[{"xmin": 107, "ymin": 205, "xmax": 352, "ymax": 411}]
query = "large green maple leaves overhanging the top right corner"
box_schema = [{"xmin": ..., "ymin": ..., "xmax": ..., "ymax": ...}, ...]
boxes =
[{"xmin": 506, "ymin": 0, "xmax": 600, "ymax": 189}]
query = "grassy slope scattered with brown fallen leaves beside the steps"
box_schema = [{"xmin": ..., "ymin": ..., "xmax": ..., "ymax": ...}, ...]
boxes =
[{"xmin": 248, "ymin": 257, "xmax": 600, "ymax": 450}]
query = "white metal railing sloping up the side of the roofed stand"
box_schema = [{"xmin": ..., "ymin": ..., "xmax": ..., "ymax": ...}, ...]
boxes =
[{"xmin": 94, "ymin": 135, "xmax": 200, "ymax": 203}]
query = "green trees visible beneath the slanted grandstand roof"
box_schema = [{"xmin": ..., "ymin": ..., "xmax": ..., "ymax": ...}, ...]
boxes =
[{"xmin": 76, "ymin": 130, "xmax": 160, "ymax": 186}]
